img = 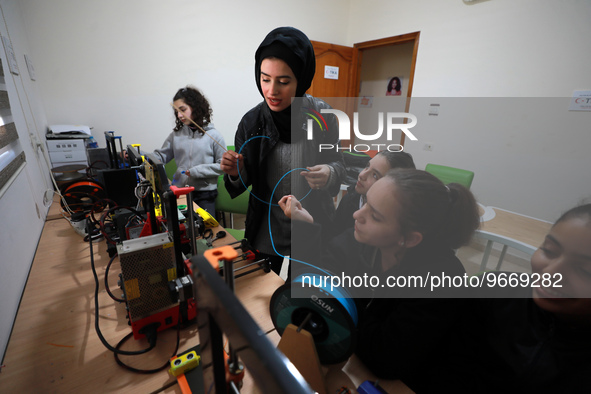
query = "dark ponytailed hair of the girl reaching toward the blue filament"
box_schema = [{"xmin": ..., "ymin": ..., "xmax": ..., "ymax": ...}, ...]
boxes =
[{"xmin": 386, "ymin": 169, "xmax": 480, "ymax": 249}]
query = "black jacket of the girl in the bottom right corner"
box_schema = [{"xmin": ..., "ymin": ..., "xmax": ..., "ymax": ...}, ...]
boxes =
[{"xmin": 442, "ymin": 288, "xmax": 591, "ymax": 393}]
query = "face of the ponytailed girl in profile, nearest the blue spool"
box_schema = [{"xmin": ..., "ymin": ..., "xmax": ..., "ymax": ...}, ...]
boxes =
[{"xmin": 353, "ymin": 178, "xmax": 403, "ymax": 249}]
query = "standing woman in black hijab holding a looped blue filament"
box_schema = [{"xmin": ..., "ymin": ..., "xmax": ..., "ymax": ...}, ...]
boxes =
[{"xmin": 221, "ymin": 27, "xmax": 345, "ymax": 273}]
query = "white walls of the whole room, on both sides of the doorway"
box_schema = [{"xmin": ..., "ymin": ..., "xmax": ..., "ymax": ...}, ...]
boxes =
[{"xmin": 0, "ymin": 0, "xmax": 591, "ymax": 360}]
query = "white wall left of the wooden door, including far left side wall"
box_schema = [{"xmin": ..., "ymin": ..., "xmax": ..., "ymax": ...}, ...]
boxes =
[{"xmin": 0, "ymin": 0, "xmax": 348, "ymax": 364}]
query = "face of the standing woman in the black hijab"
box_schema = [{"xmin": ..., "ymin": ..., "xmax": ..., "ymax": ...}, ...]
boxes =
[{"xmin": 260, "ymin": 58, "xmax": 298, "ymax": 112}]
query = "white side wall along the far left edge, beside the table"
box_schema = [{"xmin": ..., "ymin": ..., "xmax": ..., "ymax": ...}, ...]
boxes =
[{"xmin": 0, "ymin": 0, "xmax": 52, "ymax": 358}]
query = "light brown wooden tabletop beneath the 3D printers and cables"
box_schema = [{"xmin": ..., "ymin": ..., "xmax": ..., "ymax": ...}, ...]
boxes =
[{"xmin": 0, "ymin": 197, "xmax": 412, "ymax": 393}]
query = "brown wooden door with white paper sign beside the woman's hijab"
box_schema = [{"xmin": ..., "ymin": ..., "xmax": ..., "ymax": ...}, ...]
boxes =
[{"xmin": 308, "ymin": 41, "xmax": 359, "ymax": 146}]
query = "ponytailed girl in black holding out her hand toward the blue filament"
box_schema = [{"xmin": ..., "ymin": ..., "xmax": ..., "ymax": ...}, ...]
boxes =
[{"xmin": 280, "ymin": 169, "xmax": 480, "ymax": 392}]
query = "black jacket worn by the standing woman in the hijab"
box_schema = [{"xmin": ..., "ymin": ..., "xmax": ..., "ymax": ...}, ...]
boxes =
[{"xmin": 224, "ymin": 95, "xmax": 345, "ymax": 248}]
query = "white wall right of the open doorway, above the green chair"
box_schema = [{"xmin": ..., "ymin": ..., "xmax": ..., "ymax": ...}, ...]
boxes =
[{"xmin": 347, "ymin": 0, "xmax": 591, "ymax": 221}]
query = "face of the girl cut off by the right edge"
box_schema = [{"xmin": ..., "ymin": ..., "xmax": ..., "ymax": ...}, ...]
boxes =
[{"xmin": 531, "ymin": 218, "xmax": 591, "ymax": 321}]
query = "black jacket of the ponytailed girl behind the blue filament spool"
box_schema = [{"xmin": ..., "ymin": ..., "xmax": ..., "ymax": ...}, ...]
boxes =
[{"xmin": 292, "ymin": 222, "xmax": 467, "ymax": 389}]
